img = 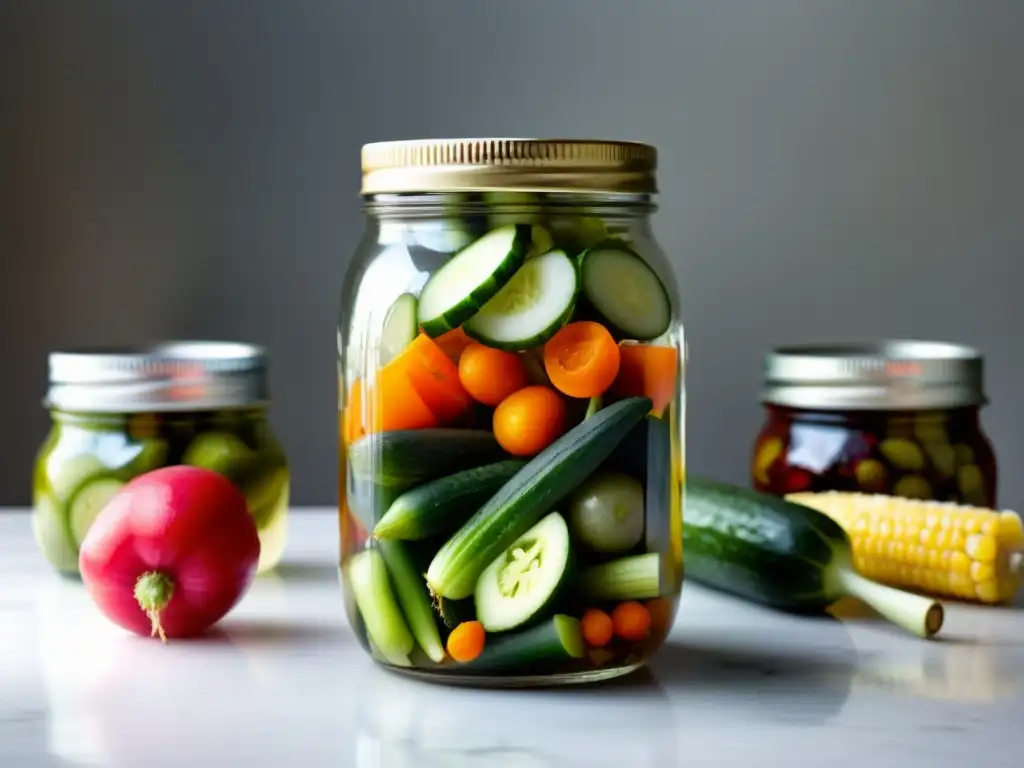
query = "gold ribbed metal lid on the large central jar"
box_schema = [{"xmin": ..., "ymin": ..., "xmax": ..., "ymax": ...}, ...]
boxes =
[{"xmin": 361, "ymin": 138, "xmax": 657, "ymax": 195}]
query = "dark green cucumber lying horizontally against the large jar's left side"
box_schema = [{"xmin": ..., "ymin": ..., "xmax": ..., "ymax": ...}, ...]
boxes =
[{"xmin": 348, "ymin": 428, "xmax": 512, "ymax": 487}]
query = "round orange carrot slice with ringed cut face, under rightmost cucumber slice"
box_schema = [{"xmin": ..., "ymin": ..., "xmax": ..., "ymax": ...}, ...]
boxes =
[{"xmin": 544, "ymin": 321, "xmax": 618, "ymax": 397}]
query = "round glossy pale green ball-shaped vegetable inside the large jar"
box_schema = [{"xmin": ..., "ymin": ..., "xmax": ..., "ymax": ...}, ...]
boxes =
[{"xmin": 569, "ymin": 472, "xmax": 644, "ymax": 553}]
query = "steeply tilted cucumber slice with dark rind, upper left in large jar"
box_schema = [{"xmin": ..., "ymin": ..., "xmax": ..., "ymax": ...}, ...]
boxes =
[{"xmin": 417, "ymin": 224, "xmax": 530, "ymax": 338}]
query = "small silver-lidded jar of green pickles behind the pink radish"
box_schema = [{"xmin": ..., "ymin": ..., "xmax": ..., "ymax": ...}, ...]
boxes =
[{"xmin": 32, "ymin": 342, "xmax": 290, "ymax": 577}]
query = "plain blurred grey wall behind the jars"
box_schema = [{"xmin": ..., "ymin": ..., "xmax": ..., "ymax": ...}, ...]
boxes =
[{"xmin": 0, "ymin": 0, "xmax": 1024, "ymax": 508}]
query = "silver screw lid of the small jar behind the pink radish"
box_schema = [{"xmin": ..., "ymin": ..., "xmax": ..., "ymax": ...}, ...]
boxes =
[{"xmin": 43, "ymin": 341, "xmax": 268, "ymax": 414}]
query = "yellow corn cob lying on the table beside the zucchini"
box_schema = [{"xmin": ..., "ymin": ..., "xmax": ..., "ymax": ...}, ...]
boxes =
[{"xmin": 786, "ymin": 492, "xmax": 1024, "ymax": 603}]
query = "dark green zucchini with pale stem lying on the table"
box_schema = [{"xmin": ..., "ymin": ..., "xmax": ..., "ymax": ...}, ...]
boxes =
[{"xmin": 683, "ymin": 477, "xmax": 943, "ymax": 637}]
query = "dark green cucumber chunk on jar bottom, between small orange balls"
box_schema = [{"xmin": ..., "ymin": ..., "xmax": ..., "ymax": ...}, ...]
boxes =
[{"xmin": 451, "ymin": 613, "xmax": 586, "ymax": 675}]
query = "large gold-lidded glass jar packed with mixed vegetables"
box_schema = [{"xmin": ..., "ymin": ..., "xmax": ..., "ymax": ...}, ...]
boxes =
[{"xmin": 338, "ymin": 139, "xmax": 685, "ymax": 686}]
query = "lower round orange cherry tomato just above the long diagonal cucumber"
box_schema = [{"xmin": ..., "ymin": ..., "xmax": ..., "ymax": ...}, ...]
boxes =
[{"xmin": 494, "ymin": 385, "xmax": 566, "ymax": 456}]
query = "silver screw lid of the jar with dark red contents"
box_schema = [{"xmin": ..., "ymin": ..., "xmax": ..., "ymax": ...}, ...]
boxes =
[{"xmin": 761, "ymin": 339, "xmax": 987, "ymax": 411}]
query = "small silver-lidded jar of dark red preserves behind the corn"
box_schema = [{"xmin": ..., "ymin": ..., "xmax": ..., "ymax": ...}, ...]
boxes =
[{"xmin": 751, "ymin": 341, "xmax": 996, "ymax": 508}]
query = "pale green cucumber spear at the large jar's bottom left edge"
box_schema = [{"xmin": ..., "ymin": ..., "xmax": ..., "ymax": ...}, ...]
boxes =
[{"xmin": 348, "ymin": 549, "xmax": 416, "ymax": 667}]
